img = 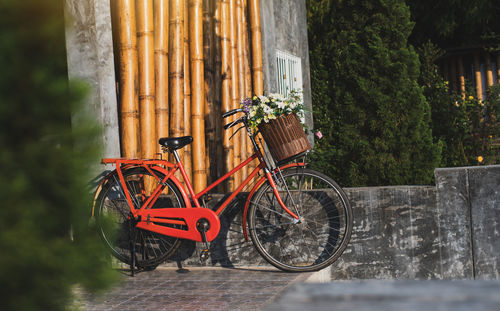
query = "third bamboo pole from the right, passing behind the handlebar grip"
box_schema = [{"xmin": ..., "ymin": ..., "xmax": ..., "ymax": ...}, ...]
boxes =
[{"xmin": 229, "ymin": 0, "xmax": 241, "ymax": 186}]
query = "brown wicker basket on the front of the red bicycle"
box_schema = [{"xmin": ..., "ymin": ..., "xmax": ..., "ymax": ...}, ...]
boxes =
[{"xmin": 259, "ymin": 113, "xmax": 311, "ymax": 163}]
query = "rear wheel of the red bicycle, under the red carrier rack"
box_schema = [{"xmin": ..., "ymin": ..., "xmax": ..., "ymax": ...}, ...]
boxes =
[{"xmin": 94, "ymin": 167, "xmax": 185, "ymax": 269}]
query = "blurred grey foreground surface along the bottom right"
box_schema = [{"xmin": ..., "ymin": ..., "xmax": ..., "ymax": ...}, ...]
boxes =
[{"xmin": 264, "ymin": 280, "xmax": 500, "ymax": 311}]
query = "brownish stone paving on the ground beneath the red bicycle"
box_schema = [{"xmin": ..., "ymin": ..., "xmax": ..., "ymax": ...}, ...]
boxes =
[{"xmin": 79, "ymin": 267, "xmax": 311, "ymax": 311}]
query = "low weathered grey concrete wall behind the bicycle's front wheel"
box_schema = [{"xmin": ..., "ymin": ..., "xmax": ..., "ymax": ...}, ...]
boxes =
[{"xmin": 166, "ymin": 166, "xmax": 500, "ymax": 279}]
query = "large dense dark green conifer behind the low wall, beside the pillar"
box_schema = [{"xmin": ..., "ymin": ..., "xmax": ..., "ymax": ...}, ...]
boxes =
[{"xmin": 307, "ymin": 0, "xmax": 441, "ymax": 186}]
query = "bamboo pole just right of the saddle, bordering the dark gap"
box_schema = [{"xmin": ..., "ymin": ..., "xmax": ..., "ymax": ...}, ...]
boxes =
[{"xmin": 189, "ymin": 0, "xmax": 207, "ymax": 192}]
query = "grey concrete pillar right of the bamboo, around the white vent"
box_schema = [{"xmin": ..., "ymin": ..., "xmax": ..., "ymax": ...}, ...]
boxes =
[{"xmin": 260, "ymin": 0, "xmax": 312, "ymax": 129}]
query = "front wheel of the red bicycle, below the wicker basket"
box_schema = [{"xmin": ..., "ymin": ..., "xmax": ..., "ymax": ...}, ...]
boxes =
[{"xmin": 248, "ymin": 167, "xmax": 352, "ymax": 272}]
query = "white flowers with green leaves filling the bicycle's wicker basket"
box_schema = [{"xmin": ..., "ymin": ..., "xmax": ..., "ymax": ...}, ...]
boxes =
[{"xmin": 240, "ymin": 90, "xmax": 305, "ymax": 130}]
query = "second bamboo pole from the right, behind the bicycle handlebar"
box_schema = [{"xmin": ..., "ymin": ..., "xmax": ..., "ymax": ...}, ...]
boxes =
[{"xmin": 235, "ymin": 0, "xmax": 248, "ymax": 180}]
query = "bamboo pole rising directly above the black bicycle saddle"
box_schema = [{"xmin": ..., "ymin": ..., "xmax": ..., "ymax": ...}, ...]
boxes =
[{"xmin": 168, "ymin": 0, "xmax": 184, "ymax": 171}]
